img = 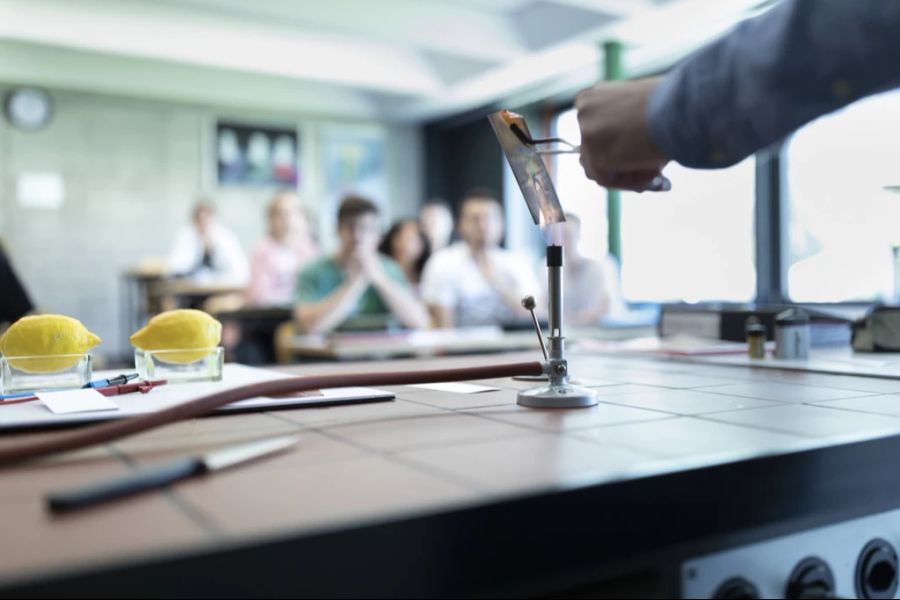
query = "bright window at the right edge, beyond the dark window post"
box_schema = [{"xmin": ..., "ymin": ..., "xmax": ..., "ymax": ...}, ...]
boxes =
[{"xmin": 786, "ymin": 92, "xmax": 900, "ymax": 302}]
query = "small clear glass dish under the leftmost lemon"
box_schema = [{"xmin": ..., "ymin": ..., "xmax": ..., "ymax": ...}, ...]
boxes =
[{"xmin": 0, "ymin": 353, "xmax": 92, "ymax": 394}]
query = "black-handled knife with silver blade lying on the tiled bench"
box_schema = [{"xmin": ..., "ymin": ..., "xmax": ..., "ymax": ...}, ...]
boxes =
[{"xmin": 47, "ymin": 436, "xmax": 300, "ymax": 512}]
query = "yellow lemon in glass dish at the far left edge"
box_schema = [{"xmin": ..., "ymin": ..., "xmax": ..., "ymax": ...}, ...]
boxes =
[{"xmin": 0, "ymin": 315, "xmax": 100, "ymax": 373}]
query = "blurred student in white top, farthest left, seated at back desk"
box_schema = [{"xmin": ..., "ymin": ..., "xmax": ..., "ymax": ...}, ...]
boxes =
[{"xmin": 167, "ymin": 202, "xmax": 250, "ymax": 287}]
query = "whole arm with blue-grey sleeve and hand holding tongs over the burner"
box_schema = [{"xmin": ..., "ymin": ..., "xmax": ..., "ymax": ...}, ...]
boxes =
[{"xmin": 575, "ymin": 0, "xmax": 900, "ymax": 190}]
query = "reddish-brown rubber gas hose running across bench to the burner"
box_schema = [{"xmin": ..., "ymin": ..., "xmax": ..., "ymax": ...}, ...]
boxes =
[{"xmin": 0, "ymin": 362, "xmax": 544, "ymax": 465}]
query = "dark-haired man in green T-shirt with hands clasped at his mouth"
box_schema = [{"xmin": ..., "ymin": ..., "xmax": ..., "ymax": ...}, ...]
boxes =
[{"xmin": 294, "ymin": 196, "xmax": 429, "ymax": 333}]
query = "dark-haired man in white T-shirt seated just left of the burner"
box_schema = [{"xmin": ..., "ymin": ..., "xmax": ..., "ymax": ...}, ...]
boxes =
[{"xmin": 422, "ymin": 190, "xmax": 542, "ymax": 327}]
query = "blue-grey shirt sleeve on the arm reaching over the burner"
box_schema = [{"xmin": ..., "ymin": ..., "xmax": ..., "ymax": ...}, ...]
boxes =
[{"xmin": 647, "ymin": 0, "xmax": 900, "ymax": 168}]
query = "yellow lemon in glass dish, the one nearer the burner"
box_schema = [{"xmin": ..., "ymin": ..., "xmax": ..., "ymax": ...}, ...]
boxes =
[{"xmin": 129, "ymin": 309, "xmax": 222, "ymax": 364}]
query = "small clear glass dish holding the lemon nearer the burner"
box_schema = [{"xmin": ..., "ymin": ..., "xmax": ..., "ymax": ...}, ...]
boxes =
[{"xmin": 134, "ymin": 346, "xmax": 225, "ymax": 383}]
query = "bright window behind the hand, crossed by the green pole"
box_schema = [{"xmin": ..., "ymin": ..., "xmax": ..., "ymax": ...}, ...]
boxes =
[{"xmin": 556, "ymin": 110, "xmax": 756, "ymax": 302}]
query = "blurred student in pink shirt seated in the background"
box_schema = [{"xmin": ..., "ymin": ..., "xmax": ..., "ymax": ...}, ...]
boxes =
[{"xmin": 245, "ymin": 192, "xmax": 319, "ymax": 306}]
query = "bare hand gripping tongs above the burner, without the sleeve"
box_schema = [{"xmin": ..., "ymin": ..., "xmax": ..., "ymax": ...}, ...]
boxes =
[{"xmin": 575, "ymin": 78, "xmax": 668, "ymax": 192}]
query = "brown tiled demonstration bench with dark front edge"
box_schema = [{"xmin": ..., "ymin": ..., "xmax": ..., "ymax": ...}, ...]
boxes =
[{"xmin": 0, "ymin": 352, "xmax": 900, "ymax": 597}]
